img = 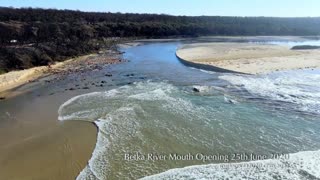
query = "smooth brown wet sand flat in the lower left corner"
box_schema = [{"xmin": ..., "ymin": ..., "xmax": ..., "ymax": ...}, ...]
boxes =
[{"xmin": 0, "ymin": 90, "xmax": 96, "ymax": 179}]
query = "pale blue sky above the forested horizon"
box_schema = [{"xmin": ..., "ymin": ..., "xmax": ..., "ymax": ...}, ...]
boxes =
[{"xmin": 0, "ymin": 0, "xmax": 320, "ymax": 17}]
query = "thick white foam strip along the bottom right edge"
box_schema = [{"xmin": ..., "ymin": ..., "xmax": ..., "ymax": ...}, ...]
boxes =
[{"xmin": 142, "ymin": 151, "xmax": 320, "ymax": 180}]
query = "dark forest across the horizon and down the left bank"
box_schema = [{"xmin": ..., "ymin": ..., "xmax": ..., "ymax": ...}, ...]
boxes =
[{"xmin": 0, "ymin": 8, "xmax": 320, "ymax": 72}]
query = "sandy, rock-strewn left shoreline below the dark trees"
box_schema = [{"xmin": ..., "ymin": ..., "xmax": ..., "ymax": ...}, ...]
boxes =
[{"xmin": 0, "ymin": 49, "xmax": 124, "ymax": 100}]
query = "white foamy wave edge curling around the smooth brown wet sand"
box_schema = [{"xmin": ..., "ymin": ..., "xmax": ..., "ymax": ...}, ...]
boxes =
[{"xmin": 58, "ymin": 82, "xmax": 200, "ymax": 180}]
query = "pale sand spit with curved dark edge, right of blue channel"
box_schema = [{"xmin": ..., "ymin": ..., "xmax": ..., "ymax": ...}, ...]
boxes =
[{"xmin": 176, "ymin": 43, "xmax": 320, "ymax": 74}]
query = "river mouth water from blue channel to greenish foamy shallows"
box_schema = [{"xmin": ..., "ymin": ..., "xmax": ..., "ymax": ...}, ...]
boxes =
[{"xmin": 59, "ymin": 39, "xmax": 320, "ymax": 179}]
